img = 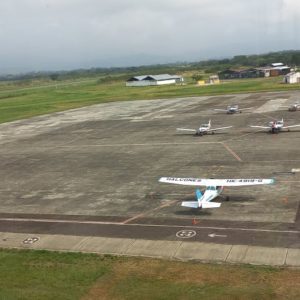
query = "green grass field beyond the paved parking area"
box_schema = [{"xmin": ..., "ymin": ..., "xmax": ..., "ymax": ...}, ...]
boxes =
[{"xmin": 0, "ymin": 77, "xmax": 300, "ymax": 123}]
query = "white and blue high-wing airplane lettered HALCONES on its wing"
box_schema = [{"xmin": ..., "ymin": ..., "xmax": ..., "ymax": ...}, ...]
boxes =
[{"xmin": 159, "ymin": 177, "xmax": 275, "ymax": 208}]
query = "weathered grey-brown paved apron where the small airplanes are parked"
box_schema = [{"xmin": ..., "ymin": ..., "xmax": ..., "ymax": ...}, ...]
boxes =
[{"xmin": 0, "ymin": 91, "xmax": 300, "ymax": 261}]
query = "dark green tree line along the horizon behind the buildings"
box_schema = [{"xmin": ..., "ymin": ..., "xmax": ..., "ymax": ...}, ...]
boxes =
[{"xmin": 0, "ymin": 50, "xmax": 300, "ymax": 82}]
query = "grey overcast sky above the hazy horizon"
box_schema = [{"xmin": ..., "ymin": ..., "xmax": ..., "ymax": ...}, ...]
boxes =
[{"xmin": 0, "ymin": 0, "xmax": 300, "ymax": 73}]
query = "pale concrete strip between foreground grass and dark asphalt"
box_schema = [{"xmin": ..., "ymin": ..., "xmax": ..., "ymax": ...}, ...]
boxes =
[{"xmin": 0, "ymin": 233, "xmax": 300, "ymax": 267}]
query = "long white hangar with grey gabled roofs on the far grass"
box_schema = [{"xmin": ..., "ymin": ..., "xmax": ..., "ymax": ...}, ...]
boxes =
[{"xmin": 126, "ymin": 74, "xmax": 183, "ymax": 86}]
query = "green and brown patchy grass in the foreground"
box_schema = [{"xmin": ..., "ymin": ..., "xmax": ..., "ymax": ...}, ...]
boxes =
[{"xmin": 0, "ymin": 250, "xmax": 300, "ymax": 300}]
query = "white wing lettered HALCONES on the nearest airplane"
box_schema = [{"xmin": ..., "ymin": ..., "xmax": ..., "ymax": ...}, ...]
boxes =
[{"xmin": 159, "ymin": 177, "xmax": 275, "ymax": 186}]
